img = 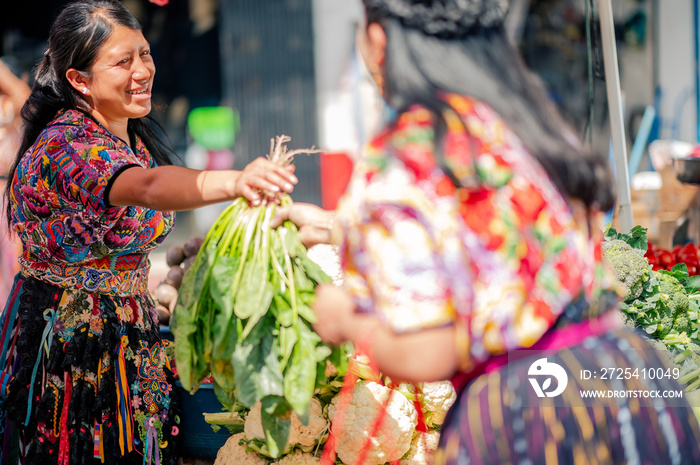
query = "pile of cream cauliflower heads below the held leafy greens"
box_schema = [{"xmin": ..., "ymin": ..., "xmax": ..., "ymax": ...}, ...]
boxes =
[{"xmin": 208, "ymin": 356, "xmax": 457, "ymax": 465}]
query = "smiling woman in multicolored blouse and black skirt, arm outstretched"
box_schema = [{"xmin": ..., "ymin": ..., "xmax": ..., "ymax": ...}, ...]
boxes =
[{"xmin": 0, "ymin": 0, "xmax": 297, "ymax": 464}]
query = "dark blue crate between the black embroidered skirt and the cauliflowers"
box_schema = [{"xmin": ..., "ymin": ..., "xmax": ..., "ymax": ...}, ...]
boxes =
[{"xmin": 175, "ymin": 382, "xmax": 231, "ymax": 459}]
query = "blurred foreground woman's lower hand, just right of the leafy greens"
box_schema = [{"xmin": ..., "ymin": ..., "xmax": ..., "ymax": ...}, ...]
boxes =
[{"xmin": 313, "ymin": 284, "xmax": 355, "ymax": 345}]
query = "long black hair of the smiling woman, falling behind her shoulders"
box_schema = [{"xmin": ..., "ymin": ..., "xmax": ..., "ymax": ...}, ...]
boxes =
[{"xmin": 5, "ymin": 0, "xmax": 172, "ymax": 223}]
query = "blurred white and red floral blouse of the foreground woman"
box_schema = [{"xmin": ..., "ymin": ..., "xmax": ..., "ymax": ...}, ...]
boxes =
[{"xmin": 334, "ymin": 95, "xmax": 614, "ymax": 370}]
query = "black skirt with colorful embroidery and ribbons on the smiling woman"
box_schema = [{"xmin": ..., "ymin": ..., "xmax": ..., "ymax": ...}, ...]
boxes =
[{"xmin": 0, "ymin": 275, "xmax": 180, "ymax": 465}]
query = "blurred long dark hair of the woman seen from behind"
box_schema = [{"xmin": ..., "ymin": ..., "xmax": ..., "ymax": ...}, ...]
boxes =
[{"xmin": 363, "ymin": 0, "xmax": 615, "ymax": 210}]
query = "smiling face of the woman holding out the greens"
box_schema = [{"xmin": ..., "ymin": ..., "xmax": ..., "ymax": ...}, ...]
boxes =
[{"xmin": 78, "ymin": 26, "xmax": 156, "ymax": 123}]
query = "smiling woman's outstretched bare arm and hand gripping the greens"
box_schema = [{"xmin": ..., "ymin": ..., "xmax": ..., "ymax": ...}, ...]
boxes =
[{"xmin": 105, "ymin": 158, "xmax": 298, "ymax": 211}]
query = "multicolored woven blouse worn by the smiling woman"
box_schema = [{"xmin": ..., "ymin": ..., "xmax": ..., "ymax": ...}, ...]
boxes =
[{"xmin": 11, "ymin": 110, "xmax": 173, "ymax": 296}]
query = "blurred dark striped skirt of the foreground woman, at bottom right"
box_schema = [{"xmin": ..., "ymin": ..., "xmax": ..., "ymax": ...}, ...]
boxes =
[{"xmin": 432, "ymin": 330, "xmax": 700, "ymax": 465}]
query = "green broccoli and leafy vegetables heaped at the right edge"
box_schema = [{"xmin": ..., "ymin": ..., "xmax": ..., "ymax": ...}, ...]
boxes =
[{"xmin": 601, "ymin": 226, "xmax": 700, "ymax": 391}]
